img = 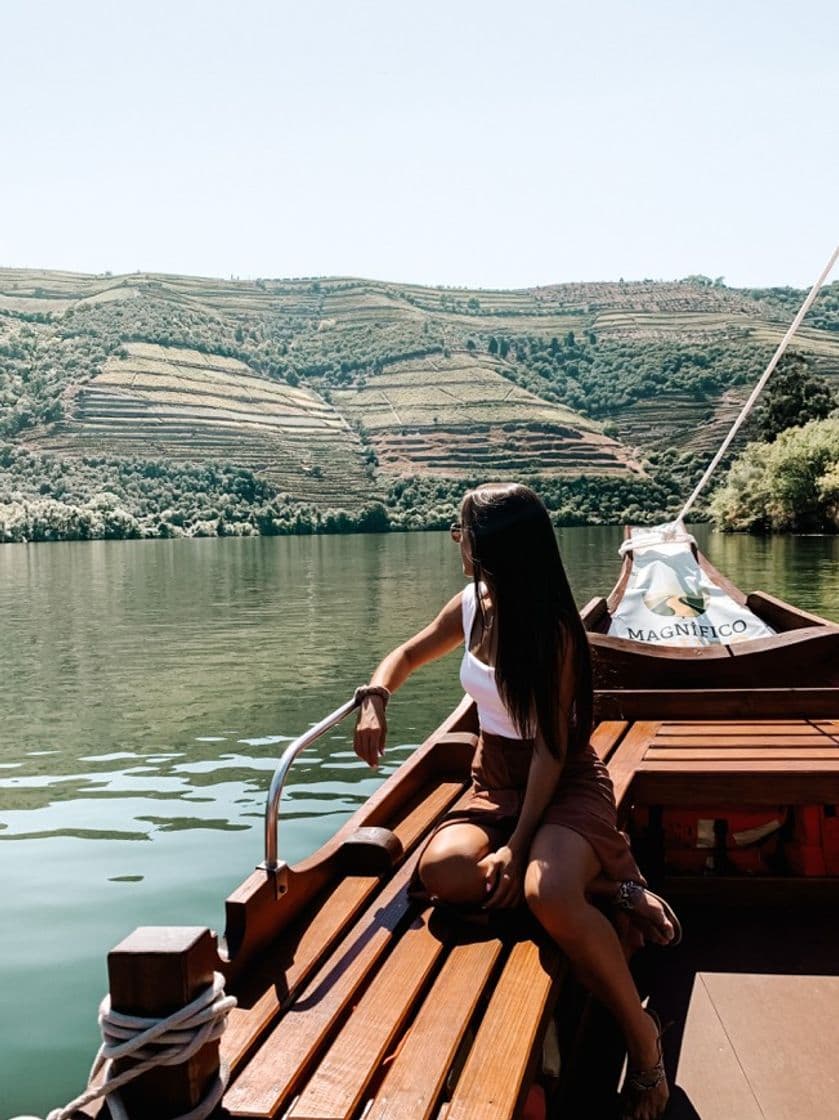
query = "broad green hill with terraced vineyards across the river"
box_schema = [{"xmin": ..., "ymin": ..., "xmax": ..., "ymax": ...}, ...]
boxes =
[{"xmin": 0, "ymin": 269, "xmax": 839, "ymax": 539}]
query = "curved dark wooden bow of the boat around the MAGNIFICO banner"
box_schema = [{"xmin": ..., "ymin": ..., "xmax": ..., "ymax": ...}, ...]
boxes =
[{"xmin": 580, "ymin": 526, "xmax": 839, "ymax": 690}]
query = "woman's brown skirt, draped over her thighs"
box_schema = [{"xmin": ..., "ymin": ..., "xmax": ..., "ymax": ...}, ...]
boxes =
[{"xmin": 439, "ymin": 731, "xmax": 645, "ymax": 884}]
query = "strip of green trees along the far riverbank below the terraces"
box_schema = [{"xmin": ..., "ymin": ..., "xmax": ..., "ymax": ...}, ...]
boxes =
[{"xmin": 0, "ymin": 447, "xmax": 682, "ymax": 543}]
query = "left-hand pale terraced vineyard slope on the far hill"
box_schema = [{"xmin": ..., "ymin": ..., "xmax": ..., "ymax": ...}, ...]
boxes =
[{"xmin": 40, "ymin": 343, "xmax": 370, "ymax": 510}]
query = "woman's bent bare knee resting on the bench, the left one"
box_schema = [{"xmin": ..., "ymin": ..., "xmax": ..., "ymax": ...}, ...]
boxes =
[{"xmin": 419, "ymin": 822, "xmax": 501, "ymax": 905}]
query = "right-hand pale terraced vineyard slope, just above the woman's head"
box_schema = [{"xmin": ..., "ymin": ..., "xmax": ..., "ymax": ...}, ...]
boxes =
[{"xmin": 333, "ymin": 351, "xmax": 640, "ymax": 477}]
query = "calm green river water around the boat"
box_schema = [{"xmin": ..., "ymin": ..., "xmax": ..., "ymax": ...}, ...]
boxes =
[{"xmin": 0, "ymin": 526, "xmax": 839, "ymax": 1118}]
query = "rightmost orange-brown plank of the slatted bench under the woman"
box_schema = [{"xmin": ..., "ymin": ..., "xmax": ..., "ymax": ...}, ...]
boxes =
[{"xmin": 446, "ymin": 941, "xmax": 565, "ymax": 1120}]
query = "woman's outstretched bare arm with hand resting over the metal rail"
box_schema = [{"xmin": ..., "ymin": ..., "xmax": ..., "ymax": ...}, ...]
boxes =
[{"xmin": 354, "ymin": 591, "xmax": 463, "ymax": 766}]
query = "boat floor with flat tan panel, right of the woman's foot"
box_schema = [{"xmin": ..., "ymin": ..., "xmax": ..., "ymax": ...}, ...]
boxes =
[{"xmin": 556, "ymin": 902, "xmax": 839, "ymax": 1120}]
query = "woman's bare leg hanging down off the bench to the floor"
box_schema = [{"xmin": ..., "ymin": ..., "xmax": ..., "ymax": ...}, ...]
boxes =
[{"xmin": 524, "ymin": 824, "xmax": 669, "ymax": 1120}]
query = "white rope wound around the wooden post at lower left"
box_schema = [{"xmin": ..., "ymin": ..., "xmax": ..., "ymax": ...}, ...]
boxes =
[{"xmin": 12, "ymin": 972, "xmax": 236, "ymax": 1120}]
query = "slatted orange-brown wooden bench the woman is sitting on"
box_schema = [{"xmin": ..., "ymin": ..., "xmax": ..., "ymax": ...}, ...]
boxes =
[{"xmin": 96, "ymin": 721, "xmax": 627, "ymax": 1120}]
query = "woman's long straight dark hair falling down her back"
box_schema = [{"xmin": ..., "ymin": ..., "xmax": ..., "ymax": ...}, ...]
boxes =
[{"xmin": 460, "ymin": 483, "xmax": 593, "ymax": 758}]
